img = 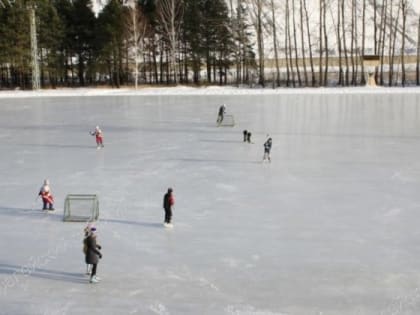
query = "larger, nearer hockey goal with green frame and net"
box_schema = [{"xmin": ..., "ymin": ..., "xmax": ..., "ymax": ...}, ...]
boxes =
[{"xmin": 63, "ymin": 194, "xmax": 99, "ymax": 222}]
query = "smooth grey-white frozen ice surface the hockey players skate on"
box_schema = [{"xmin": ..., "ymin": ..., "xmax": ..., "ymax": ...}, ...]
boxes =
[{"xmin": 0, "ymin": 89, "xmax": 420, "ymax": 315}]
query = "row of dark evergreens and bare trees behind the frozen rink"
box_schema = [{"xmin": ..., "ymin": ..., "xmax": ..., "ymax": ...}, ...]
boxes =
[{"xmin": 0, "ymin": 0, "xmax": 420, "ymax": 88}]
